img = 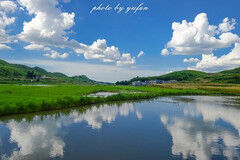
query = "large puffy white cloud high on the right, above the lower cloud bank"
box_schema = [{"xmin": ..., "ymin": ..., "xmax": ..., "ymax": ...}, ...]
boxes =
[{"xmin": 161, "ymin": 13, "xmax": 240, "ymax": 55}]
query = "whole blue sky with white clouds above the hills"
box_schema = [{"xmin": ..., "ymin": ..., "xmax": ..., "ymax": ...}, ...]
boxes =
[{"xmin": 0, "ymin": 0, "xmax": 240, "ymax": 82}]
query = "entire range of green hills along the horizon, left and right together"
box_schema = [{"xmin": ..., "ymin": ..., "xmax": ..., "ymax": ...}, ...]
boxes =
[{"xmin": 0, "ymin": 60, "xmax": 240, "ymax": 85}]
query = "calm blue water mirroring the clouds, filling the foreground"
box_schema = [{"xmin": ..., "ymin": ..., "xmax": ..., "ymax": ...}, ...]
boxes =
[{"xmin": 0, "ymin": 96, "xmax": 240, "ymax": 160}]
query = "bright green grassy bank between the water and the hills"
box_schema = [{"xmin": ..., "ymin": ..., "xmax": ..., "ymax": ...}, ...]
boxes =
[{"xmin": 0, "ymin": 84, "xmax": 240, "ymax": 116}]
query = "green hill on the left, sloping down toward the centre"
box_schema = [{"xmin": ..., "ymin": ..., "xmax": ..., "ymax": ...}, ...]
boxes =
[{"xmin": 0, "ymin": 60, "xmax": 98, "ymax": 84}]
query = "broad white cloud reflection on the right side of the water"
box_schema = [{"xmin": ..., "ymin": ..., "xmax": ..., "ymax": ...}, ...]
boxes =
[{"xmin": 160, "ymin": 97, "xmax": 240, "ymax": 160}]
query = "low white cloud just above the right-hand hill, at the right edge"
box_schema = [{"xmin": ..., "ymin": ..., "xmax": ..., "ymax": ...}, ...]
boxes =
[{"xmin": 189, "ymin": 43, "xmax": 240, "ymax": 72}]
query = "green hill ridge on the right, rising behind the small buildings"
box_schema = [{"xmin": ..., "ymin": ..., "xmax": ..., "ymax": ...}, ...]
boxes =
[{"xmin": 116, "ymin": 68, "xmax": 240, "ymax": 85}]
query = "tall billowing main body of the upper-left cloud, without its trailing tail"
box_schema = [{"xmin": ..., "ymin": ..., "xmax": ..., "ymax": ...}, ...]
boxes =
[{"xmin": 18, "ymin": 0, "xmax": 79, "ymax": 47}]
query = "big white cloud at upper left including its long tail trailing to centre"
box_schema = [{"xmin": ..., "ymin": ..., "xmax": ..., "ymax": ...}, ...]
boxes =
[{"xmin": 18, "ymin": 0, "xmax": 135, "ymax": 65}]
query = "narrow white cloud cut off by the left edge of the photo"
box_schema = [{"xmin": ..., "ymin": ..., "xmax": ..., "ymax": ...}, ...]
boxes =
[{"xmin": 0, "ymin": 0, "xmax": 17, "ymax": 50}]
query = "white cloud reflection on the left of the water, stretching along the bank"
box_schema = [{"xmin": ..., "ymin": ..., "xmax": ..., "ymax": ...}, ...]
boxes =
[{"xmin": 2, "ymin": 103, "xmax": 140, "ymax": 160}]
